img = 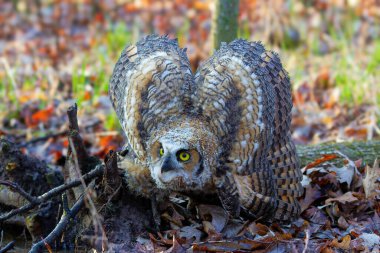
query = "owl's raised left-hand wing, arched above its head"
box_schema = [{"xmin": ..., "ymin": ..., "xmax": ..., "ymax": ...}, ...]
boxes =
[{"xmin": 109, "ymin": 35, "xmax": 193, "ymax": 162}]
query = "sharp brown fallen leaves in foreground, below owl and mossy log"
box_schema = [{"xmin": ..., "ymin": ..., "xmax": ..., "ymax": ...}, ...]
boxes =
[{"xmin": 124, "ymin": 154, "xmax": 380, "ymax": 252}]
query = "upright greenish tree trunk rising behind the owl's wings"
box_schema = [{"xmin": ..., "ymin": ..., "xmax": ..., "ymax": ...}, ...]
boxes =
[{"xmin": 212, "ymin": 0, "xmax": 239, "ymax": 49}]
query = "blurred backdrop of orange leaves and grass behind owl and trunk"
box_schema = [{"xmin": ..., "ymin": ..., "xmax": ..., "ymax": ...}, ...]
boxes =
[{"xmin": 0, "ymin": 0, "xmax": 380, "ymax": 165}]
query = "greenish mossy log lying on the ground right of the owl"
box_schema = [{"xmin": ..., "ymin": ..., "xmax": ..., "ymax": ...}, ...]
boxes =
[{"xmin": 297, "ymin": 140, "xmax": 380, "ymax": 167}]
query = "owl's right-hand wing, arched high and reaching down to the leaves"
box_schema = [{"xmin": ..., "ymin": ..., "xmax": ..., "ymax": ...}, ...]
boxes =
[{"xmin": 193, "ymin": 40, "xmax": 300, "ymax": 219}]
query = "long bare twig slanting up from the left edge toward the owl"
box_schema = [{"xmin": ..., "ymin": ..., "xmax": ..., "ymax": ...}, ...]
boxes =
[{"xmin": 0, "ymin": 164, "xmax": 104, "ymax": 222}]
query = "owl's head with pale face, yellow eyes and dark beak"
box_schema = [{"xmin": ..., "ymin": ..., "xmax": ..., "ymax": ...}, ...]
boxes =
[{"xmin": 148, "ymin": 122, "xmax": 219, "ymax": 191}]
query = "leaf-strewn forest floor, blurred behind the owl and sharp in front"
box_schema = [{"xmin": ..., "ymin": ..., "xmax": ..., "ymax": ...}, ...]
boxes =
[{"xmin": 0, "ymin": 0, "xmax": 380, "ymax": 252}]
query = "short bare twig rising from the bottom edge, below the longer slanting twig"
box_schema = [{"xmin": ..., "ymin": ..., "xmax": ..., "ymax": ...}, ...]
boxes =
[{"xmin": 29, "ymin": 197, "xmax": 84, "ymax": 253}]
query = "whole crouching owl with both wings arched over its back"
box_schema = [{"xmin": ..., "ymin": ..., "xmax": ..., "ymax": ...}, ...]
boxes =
[{"xmin": 109, "ymin": 35, "xmax": 302, "ymax": 221}]
